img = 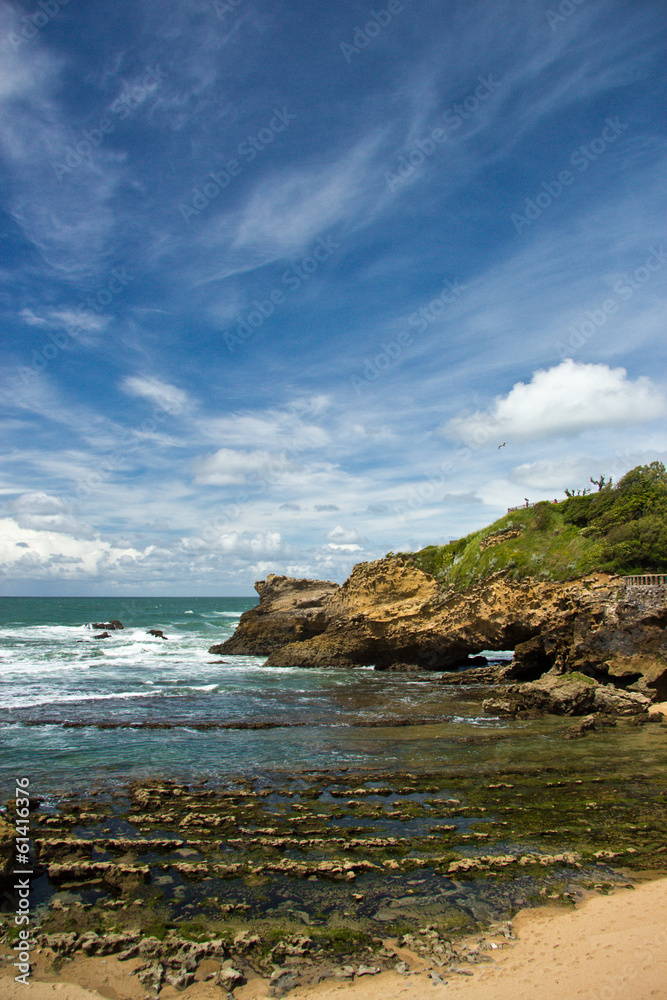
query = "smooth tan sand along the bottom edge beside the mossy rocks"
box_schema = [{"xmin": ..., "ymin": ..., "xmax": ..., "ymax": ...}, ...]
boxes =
[{"xmin": 0, "ymin": 878, "xmax": 667, "ymax": 1000}]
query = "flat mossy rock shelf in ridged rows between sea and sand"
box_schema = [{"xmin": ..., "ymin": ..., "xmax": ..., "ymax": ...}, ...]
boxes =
[{"xmin": 0, "ymin": 748, "xmax": 667, "ymax": 1000}]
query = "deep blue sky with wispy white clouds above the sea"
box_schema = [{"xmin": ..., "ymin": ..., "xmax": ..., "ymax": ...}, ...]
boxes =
[{"xmin": 0, "ymin": 0, "xmax": 667, "ymax": 595}]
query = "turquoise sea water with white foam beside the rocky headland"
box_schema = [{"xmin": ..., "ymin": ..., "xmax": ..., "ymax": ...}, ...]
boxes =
[{"xmin": 0, "ymin": 597, "xmax": 664, "ymax": 795}]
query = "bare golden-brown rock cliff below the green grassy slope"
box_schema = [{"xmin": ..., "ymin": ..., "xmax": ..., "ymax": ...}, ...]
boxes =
[{"xmin": 211, "ymin": 557, "xmax": 667, "ymax": 699}]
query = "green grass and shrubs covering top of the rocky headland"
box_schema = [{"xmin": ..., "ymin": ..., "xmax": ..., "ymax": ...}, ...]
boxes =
[{"xmin": 402, "ymin": 462, "xmax": 667, "ymax": 590}]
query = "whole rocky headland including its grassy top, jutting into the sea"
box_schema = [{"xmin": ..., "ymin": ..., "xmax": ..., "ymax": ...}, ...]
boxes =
[{"xmin": 210, "ymin": 462, "xmax": 667, "ymax": 715}]
